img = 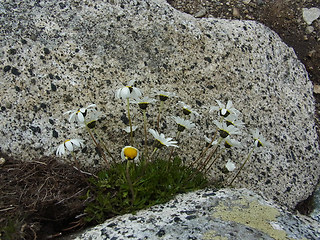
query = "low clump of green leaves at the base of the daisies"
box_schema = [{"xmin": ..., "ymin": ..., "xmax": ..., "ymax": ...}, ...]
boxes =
[{"xmin": 85, "ymin": 158, "xmax": 208, "ymax": 223}]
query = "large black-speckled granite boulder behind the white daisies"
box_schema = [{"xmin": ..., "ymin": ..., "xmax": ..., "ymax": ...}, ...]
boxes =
[{"xmin": 0, "ymin": 0, "xmax": 320, "ymax": 207}]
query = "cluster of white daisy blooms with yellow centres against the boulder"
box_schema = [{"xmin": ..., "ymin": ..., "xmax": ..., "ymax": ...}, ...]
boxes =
[{"xmin": 56, "ymin": 80, "xmax": 271, "ymax": 183}]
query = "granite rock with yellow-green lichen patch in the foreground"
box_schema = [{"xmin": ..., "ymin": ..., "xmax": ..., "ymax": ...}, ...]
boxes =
[{"xmin": 68, "ymin": 189, "xmax": 320, "ymax": 240}]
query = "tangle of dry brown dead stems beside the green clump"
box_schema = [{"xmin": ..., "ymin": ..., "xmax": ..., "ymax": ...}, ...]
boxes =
[{"xmin": 0, "ymin": 153, "xmax": 88, "ymax": 239}]
